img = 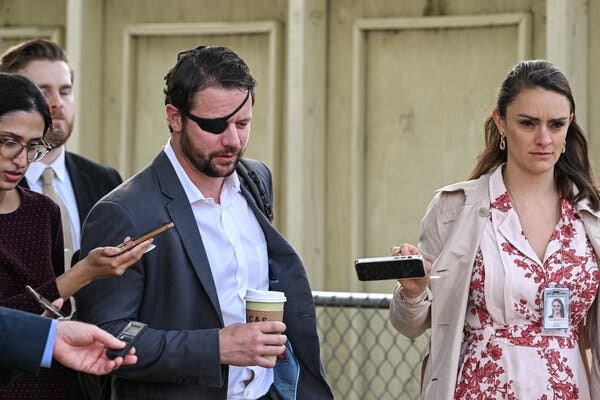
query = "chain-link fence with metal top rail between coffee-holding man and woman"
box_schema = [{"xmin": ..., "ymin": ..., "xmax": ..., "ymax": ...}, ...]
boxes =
[{"xmin": 313, "ymin": 291, "xmax": 428, "ymax": 400}]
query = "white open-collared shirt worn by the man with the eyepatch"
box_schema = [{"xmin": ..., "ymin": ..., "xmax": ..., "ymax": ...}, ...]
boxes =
[{"xmin": 164, "ymin": 140, "xmax": 273, "ymax": 400}]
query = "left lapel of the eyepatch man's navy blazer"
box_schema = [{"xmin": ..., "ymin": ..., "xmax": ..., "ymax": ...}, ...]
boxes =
[{"xmin": 152, "ymin": 152, "xmax": 223, "ymax": 325}]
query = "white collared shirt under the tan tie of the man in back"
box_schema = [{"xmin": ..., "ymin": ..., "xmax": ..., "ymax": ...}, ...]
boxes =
[{"xmin": 25, "ymin": 146, "xmax": 81, "ymax": 251}]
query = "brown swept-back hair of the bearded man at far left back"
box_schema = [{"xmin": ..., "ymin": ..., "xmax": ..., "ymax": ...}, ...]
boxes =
[{"xmin": 0, "ymin": 39, "xmax": 73, "ymax": 82}]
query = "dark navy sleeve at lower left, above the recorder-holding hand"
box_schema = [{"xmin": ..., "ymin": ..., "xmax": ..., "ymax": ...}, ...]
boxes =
[{"xmin": 0, "ymin": 307, "xmax": 51, "ymax": 385}]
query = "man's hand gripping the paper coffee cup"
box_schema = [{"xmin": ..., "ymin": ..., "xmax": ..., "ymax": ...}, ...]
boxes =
[{"xmin": 219, "ymin": 321, "xmax": 287, "ymax": 368}]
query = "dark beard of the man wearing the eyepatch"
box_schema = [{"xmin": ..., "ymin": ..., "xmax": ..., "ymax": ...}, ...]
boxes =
[{"xmin": 181, "ymin": 131, "xmax": 244, "ymax": 178}]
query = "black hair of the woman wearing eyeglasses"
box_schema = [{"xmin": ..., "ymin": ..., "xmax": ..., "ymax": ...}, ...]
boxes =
[{"xmin": 0, "ymin": 72, "xmax": 52, "ymax": 134}]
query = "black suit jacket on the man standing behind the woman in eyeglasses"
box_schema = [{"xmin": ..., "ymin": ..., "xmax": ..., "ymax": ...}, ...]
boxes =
[{"xmin": 19, "ymin": 151, "xmax": 123, "ymax": 225}]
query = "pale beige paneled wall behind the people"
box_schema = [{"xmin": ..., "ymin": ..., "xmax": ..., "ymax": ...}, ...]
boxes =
[{"xmin": 0, "ymin": 0, "xmax": 600, "ymax": 292}]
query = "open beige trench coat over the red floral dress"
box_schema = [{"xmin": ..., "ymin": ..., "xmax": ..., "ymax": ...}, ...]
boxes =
[{"xmin": 390, "ymin": 174, "xmax": 600, "ymax": 400}]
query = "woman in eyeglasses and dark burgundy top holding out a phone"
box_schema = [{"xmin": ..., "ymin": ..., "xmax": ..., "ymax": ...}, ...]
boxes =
[{"xmin": 0, "ymin": 73, "xmax": 151, "ymax": 399}]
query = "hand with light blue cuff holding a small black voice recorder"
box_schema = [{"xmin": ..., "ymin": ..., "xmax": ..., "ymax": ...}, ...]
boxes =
[{"xmin": 53, "ymin": 320, "xmax": 137, "ymax": 375}]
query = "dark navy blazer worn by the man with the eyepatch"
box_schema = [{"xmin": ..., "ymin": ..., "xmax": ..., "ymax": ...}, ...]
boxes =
[{"xmin": 76, "ymin": 152, "xmax": 333, "ymax": 400}]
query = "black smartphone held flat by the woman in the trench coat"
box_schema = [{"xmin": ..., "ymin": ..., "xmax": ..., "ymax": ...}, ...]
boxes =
[{"xmin": 354, "ymin": 256, "xmax": 425, "ymax": 281}]
